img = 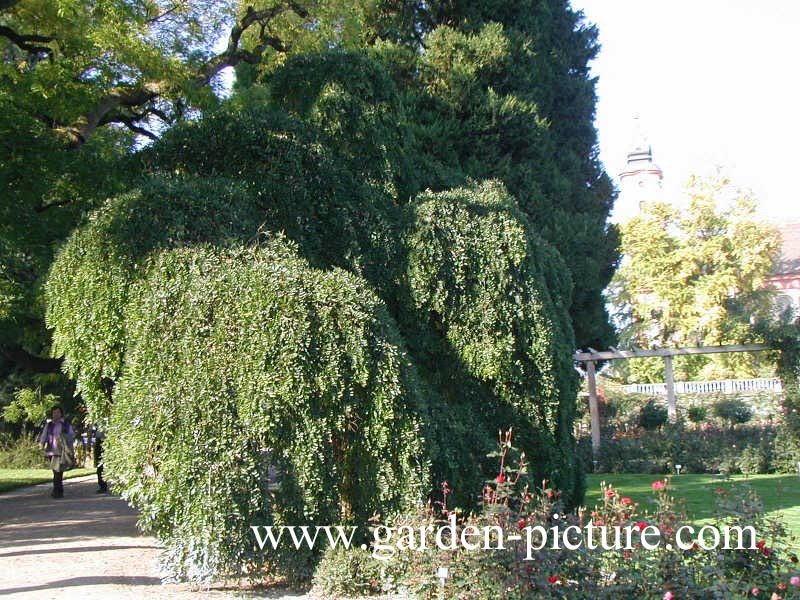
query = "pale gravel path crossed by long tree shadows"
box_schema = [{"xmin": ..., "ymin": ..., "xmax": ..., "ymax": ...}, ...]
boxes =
[{"xmin": 0, "ymin": 476, "xmax": 307, "ymax": 600}]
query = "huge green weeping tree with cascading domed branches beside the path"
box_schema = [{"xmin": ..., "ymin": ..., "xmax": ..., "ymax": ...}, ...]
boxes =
[{"xmin": 45, "ymin": 94, "xmax": 583, "ymax": 582}]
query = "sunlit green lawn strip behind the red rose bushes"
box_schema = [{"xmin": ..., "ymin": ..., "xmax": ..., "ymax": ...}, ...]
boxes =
[{"xmin": 584, "ymin": 473, "xmax": 800, "ymax": 538}]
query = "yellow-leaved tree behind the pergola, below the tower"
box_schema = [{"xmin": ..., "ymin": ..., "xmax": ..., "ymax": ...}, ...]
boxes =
[{"xmin": 609, "ymin": 176, "xmax": 780, "ymax": 381}]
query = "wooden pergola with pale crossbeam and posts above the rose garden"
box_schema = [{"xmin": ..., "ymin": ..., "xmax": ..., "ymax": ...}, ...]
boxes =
[{"xmin": 573, "ymin": 344, "xmax": 770, "ymax": 456}]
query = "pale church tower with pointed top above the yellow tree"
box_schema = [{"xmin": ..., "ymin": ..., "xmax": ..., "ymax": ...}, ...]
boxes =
[{"xmin": 611, "ymin": 117, "xmax": 664, "ymax": 223}]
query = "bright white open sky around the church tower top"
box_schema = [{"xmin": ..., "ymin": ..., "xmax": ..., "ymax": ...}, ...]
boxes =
[{"xmin": 572, "ymin": 0, "xmax": 800, "ymax": 222}]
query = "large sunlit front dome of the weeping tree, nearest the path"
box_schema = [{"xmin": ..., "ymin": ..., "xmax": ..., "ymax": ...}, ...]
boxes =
[{"xmin": 105, "ymin": 240, "xmax": 429, "ymax": 581}]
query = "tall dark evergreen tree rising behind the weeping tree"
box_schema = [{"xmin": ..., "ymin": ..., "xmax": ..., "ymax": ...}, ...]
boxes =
[{"xmin": 406, "ymin": 0, "xmax": 618, "ymax": 347}]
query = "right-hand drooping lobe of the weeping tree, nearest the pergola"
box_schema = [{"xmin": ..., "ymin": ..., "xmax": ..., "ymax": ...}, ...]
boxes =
[{"xmin": 408, "ymin": 182, "xmax": 580, "ymax": 500}]
